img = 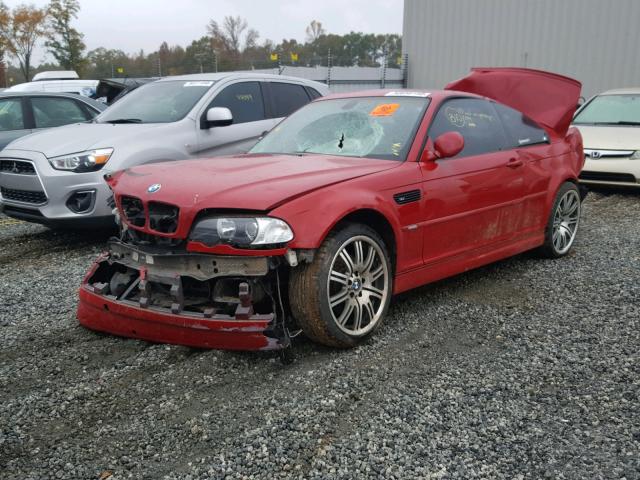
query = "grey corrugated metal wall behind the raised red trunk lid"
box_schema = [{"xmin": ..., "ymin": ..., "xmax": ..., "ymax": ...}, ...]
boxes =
[{"xmin": 402, "ymin": 0, "xmax": 640, "ymax": 97}]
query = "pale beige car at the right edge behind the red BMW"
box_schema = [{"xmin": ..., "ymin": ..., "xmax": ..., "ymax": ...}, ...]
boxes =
[{"xmin": 573, "ymin": 88, "xmax": 640, "ymax": 188}]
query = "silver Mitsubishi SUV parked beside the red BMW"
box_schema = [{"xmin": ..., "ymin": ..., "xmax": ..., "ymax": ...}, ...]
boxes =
[{"xmin": 0, "ymin": 72, "xmax": 328, "ymax": 227}]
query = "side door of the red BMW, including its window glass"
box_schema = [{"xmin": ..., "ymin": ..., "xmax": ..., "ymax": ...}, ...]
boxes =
[{"xmin": 422, "ymin": 98, "xmax": 524, "ymax": 264}]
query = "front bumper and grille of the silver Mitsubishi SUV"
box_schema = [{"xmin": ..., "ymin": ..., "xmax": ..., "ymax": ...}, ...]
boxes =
[{"xmin": 0, "ymin": 149, "xmax": 113, "ymax": 226}]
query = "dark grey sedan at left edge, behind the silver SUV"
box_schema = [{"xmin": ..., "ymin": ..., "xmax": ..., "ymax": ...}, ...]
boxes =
[{"xmin": 0, "ymin": 90, "xmax": 107, "ymax": 150}]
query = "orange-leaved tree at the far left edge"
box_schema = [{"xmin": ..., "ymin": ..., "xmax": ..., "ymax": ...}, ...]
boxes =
[{"xmin": 0, "ymin": 5, "xmax": 47, "ymax": 82}]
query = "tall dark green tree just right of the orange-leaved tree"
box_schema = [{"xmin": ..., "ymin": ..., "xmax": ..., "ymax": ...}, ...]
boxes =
[{"xmin": 45, "ymin": 0, "xmax": 86, "ymax": 73}]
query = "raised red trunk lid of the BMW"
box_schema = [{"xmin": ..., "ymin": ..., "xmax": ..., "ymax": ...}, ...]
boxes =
[{"xmin": 445, "ymin": 68, "xmax": 582, "ymax": 137}]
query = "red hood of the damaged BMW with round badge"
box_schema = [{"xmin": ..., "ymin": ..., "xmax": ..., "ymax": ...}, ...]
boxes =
[{"xmin": 108, "ymin": 154, "xmax": 401, "ymax": 212}]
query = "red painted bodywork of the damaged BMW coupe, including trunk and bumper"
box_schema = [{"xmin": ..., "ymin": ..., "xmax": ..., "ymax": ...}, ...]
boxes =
[{"xmin": 86, "ymin": 69, "xmax": 584, "ymax": 349}]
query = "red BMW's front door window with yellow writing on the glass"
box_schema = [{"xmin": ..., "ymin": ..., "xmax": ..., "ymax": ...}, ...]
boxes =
[{"xmin": 429, "ymin": 98, "xmax": 508, "ymax": 157}]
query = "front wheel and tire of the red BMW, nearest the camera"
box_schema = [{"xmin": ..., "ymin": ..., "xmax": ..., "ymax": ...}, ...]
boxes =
[{"xmin": 289, "ymin": 223, "xmax": 393, "ymax": 348}]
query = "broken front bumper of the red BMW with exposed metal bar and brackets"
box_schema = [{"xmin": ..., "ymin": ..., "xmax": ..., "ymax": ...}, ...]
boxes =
[{"xmin": 77, "ymin": 242, "xmax": 289, "ymax": 350}]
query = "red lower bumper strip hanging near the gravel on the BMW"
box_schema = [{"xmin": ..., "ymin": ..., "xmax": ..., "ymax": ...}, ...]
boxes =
[{"xmin": 78, "ymin": 285, "xmax": 285, "ymax": 350}]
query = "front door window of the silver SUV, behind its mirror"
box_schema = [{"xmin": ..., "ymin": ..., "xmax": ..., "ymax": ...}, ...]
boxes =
[{"xmin": 209, "ymin": 82, "xmax": 264, "ymax": 125}]
